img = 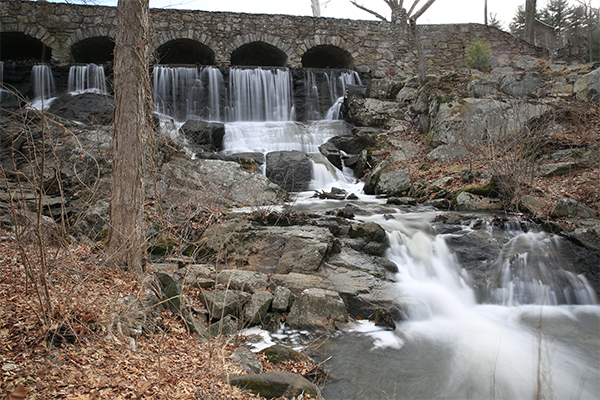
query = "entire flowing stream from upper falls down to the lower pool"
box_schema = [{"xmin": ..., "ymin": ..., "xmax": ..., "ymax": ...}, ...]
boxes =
[{"xmin": 149, "ymin": 64, "xmax": 600, "ymax": 400}]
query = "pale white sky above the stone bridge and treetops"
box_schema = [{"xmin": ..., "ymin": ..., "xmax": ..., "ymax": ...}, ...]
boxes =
[{"xmin": 68, "ymin": 0, "xmax": 600, "ymax": 30}]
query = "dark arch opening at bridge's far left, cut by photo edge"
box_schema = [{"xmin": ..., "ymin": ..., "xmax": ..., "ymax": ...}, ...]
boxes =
[{"xmin": 0, "ymin": 32, "xmax": 52, "ymax": 63}]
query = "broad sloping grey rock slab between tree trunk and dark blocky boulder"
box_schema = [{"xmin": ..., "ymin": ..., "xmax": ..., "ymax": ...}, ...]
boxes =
[{"xmin": 161, "ymin": 157, "xmax": 286, "ymax": 206}]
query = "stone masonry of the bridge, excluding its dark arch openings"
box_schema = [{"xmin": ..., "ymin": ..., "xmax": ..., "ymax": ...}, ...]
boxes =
[{"xmin": 0, "ymin": 0, "xmax": 544, "ymax": 75}]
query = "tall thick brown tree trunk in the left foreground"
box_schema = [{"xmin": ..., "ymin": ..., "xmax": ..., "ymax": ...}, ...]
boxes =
[{"xmin": 107, "ymin": 0, "xmax": 150, "ymax": 273}]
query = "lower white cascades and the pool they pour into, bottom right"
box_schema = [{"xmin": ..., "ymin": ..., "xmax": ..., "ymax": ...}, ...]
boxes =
[{"xmin": 316, "ymin": 213, "xmax": 600, "ymax": 400}]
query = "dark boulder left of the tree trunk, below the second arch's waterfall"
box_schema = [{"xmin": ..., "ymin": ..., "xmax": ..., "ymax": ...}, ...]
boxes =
[{"xmin": 48, "ymin": 93, "xmax": 115, "ymax": 125}]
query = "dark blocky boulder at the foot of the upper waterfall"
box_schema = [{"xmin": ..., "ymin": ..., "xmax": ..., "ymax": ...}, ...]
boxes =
[{"xmin": 266, "ymin": 151, "xmax": 312, "ymax": 192}]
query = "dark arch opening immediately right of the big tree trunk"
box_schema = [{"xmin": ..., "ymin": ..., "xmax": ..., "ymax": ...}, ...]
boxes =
[{"xmin": 156, "ymin": 39, "xmax": 215, "ymax": 65}]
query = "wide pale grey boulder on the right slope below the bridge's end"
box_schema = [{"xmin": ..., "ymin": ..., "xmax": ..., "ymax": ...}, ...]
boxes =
[{"xmin": 431, "ymin": 98, "xmax": 551, "ymax": 146}]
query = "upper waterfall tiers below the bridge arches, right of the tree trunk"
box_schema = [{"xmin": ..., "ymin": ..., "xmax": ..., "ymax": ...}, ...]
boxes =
[{"xmin": 153, "ymin": 66, "xmax": 360, "ymax": 188}]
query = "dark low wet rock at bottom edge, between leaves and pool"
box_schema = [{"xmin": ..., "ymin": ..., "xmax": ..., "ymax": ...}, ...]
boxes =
[{"xmin": 228, "ymin": 371, "xmax": 319, "ymax": 399}]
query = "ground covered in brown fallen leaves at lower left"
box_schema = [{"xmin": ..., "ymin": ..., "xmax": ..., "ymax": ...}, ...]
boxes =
[{"xmin": 0, "ymin": 238, "xmax": 312, "ymax": 400}]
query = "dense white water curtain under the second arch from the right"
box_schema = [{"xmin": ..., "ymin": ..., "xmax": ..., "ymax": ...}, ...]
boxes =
[{"xmin": 226, "ymin": 68, "xmax": 295, "ymax": 122}]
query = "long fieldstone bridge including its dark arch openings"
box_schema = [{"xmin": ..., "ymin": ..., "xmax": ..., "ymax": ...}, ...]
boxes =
[{"xmin": 0, "ymin": 0, "xmax": 543, "ymax": 76}]
